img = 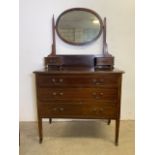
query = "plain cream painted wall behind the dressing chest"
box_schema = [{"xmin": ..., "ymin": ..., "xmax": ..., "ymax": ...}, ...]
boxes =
[{"xmin": 19, "ymin": 0, "xmax": 134, "ymax": 121}]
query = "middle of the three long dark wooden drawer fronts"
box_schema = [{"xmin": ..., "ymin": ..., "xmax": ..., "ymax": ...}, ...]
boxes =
[{"xmin": 38, "ymin": 88, "xmax": 118, "ymax": 101}]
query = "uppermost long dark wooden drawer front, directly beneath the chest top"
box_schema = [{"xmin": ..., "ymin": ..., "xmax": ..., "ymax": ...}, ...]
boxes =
[{"xmin": 37, "ymin": 74, "xmax": 119, "ymax": 87}]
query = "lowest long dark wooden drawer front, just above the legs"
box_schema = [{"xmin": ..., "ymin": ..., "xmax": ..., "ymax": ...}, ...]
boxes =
[{"xmin": 39, "ymin": 104, "xmax": 116, "ymax": 118}]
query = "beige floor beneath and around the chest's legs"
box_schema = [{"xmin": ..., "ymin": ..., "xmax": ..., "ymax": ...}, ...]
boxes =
[{"xmin": 19, "ymin": 120, "xmax": 135, "ymax": 155}]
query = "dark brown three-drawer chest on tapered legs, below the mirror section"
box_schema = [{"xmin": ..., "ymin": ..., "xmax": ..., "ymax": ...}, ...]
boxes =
[{"xmin": 35, "ymin": 69, "xmax": 123, "ymax": 145}]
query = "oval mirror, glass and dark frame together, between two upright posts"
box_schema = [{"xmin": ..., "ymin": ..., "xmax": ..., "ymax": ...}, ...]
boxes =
[{"xmin": 56, "ymin": 8, "xmax": 103, "ymax": 45}]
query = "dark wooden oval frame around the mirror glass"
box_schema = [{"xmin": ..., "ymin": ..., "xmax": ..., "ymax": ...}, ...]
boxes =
[{"xmin": 56, "ymin": 8, "xmax": 103, "ymax": 45}]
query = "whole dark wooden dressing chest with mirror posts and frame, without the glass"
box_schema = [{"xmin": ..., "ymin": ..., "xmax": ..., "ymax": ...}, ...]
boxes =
[{"xmin": 34, "ymin": 8, "xmax": 123, "ymax": 145}]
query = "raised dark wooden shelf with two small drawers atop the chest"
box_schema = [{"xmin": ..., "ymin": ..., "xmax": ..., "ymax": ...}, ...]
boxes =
[{"xmin": 44, "ymin": 55, "xmax": 114, "ymax": 70}]
